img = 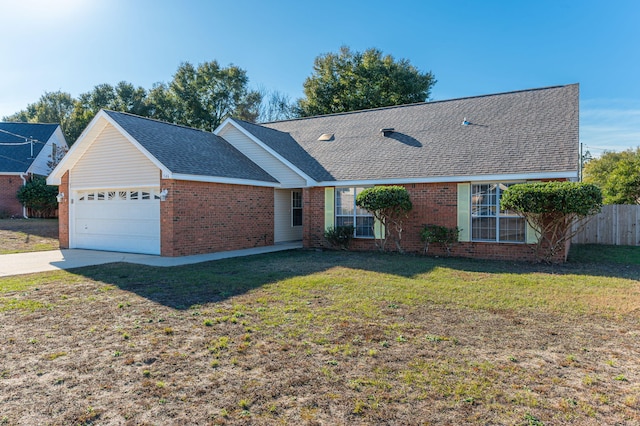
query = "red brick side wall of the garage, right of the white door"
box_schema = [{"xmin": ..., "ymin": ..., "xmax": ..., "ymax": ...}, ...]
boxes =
[{"xmin": 160, "ymin": 179, "xmax": 274, "ymax": 256}]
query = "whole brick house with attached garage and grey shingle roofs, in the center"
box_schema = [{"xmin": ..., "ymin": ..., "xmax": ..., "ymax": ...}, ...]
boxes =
[{"xmin": 49, "ymin": 84, "xmax": 578, "ymax": 260}]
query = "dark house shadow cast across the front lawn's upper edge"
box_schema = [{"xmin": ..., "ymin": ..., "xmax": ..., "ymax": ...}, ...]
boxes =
[{"xmin": 73, "ymin": 246, "xmax": 640, "ymax": 309}]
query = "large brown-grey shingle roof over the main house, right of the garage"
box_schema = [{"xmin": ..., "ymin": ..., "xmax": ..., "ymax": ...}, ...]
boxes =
[{"xmin": 240, "ymin": 84, "xmax": 579, "ymax": 181}]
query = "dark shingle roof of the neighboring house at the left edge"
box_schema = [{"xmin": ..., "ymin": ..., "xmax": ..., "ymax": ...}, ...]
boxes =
[{"xmin": 0, "ymin": 123, "xmax": 58, "ymax": 173}]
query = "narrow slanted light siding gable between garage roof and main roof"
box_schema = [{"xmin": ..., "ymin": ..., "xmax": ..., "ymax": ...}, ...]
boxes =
[{"xmin": 218, "ymin": 125, "xmax": 307, "ymax": 188}]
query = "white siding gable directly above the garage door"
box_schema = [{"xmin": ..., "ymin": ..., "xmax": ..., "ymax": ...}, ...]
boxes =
[{"xmin": 70, "ymin": 124, "xmax": 160, "ymax": 190}]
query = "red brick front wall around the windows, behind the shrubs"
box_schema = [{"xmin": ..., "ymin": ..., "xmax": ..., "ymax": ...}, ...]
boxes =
[{"xmin": 303, "ymin": 183, "xmax": 568, "ymax": 261}]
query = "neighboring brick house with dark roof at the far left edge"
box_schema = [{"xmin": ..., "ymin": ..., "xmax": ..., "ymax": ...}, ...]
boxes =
[{"xmin": 0, "ymin": 123, "xmax": 67, "ymax": 217}]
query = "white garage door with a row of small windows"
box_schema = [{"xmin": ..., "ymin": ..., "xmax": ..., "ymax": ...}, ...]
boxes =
[{"xmin": 70, "ymin": 188, "xmax": 160, "ymax": 254}]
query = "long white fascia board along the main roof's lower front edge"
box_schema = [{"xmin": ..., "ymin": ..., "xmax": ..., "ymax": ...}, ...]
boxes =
[{"xmin": 317, "ymin": 172, "xmax": 577, "ymax": 186}]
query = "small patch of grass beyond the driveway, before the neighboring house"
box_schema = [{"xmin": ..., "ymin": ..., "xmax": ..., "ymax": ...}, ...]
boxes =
[{"xmin": 0, "ymin": 219, "xmax": 60, "ymax": 255}]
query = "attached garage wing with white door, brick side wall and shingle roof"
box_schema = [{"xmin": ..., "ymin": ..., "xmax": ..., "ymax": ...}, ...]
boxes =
[{"xmin": 47, "ymin": 110, "xmax": 282, "ymax": 256}]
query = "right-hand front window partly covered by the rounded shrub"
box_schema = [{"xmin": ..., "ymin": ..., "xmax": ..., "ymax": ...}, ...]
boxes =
[{"xmin": 471, "ymin": 183, "xmax": 525, "ymax": 243}]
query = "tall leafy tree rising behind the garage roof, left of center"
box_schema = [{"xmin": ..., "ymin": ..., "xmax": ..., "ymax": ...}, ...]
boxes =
[{"xmin": 169, "ymin": 61, "xmax": 262, "ymax": 131}]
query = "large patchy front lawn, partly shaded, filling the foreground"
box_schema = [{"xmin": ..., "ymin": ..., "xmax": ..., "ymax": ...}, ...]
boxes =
[{"xmin": 0, "ymin": 251, "xmax": 640, "ymax": 425}]
